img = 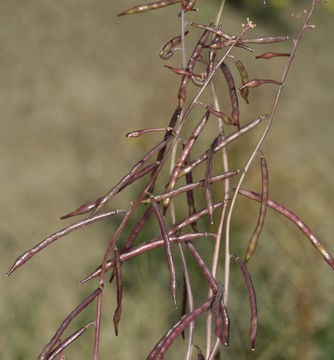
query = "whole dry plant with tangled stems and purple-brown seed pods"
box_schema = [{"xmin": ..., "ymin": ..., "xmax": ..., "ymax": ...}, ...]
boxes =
[{"xmin": 8, "ymin": 0, "xmax": 334, "ymax": 360}]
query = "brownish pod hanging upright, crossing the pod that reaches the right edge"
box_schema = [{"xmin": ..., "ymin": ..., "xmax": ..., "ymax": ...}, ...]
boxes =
[{"xmin": 245, "ymin": 155, "xmax": 269, "ymax": 263}]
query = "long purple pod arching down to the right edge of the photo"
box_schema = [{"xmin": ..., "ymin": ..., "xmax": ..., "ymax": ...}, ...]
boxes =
[{"xmin": 239, "ymin": 189, "xmax": 334, "ymax": 269}]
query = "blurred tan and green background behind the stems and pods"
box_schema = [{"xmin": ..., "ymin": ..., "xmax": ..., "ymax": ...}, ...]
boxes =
[{"xmin": 0, "ymin": 0, "xmax": 334, "ymax": 360}]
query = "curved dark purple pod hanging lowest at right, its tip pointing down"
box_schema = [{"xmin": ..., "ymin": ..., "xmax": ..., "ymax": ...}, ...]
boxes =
[{"xmin": 231, "ymin": 254, "xmax": 257, "ymax": 350}]
